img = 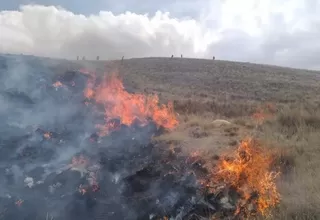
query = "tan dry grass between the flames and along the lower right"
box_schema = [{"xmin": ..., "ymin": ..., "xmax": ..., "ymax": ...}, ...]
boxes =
[{"xmin": 158, "ymin": 104, "xmax": 320, "ymax": 220}]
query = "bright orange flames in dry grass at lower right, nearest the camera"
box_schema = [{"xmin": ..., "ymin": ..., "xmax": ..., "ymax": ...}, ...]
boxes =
[{"xmin": 213, "ymin": 139, "xmax": 280, "ymax": 214}]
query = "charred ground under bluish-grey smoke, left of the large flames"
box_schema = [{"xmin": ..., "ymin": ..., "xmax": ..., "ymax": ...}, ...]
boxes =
[{"xmin": 0, "ymin": 53, "xmax": 206, "ymax": 220}]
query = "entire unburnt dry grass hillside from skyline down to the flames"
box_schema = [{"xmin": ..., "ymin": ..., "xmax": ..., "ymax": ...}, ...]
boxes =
[{"xmin": 53, "ymin": 58, "xmax": 320, "ymax": 219}]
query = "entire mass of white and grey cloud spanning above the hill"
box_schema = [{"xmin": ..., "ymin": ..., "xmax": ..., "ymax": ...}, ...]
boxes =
[{"xmin": 0, "ymin": 0, "xmax": 320, "ymax": 68}]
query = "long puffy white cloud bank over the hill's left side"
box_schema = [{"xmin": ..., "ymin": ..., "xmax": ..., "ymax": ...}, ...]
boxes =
[{"xmin": 0, "ymin": 5, "xmax": 214, "ymax": 58}]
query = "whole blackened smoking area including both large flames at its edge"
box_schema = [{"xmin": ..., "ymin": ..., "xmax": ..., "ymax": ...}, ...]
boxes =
[{"xmin": 0, "ymin": 55, "xmax": 279, "ymax": 220}]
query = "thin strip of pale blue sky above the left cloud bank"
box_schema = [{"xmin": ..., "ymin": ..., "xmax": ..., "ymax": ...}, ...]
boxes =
[{"xmin": 0, "ymin": 0, "xmax": 205, "ymax": 17}]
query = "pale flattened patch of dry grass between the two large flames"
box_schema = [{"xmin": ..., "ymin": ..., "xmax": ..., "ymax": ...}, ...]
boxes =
[{"xmin": 154, "ymin": 114, "xmax": 248, "ymax": 154}]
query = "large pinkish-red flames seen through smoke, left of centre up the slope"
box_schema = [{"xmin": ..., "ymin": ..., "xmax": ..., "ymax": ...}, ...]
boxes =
[{"xmin": 84, "ymin": 72, "xmax": 178, "ymax": 135}]
